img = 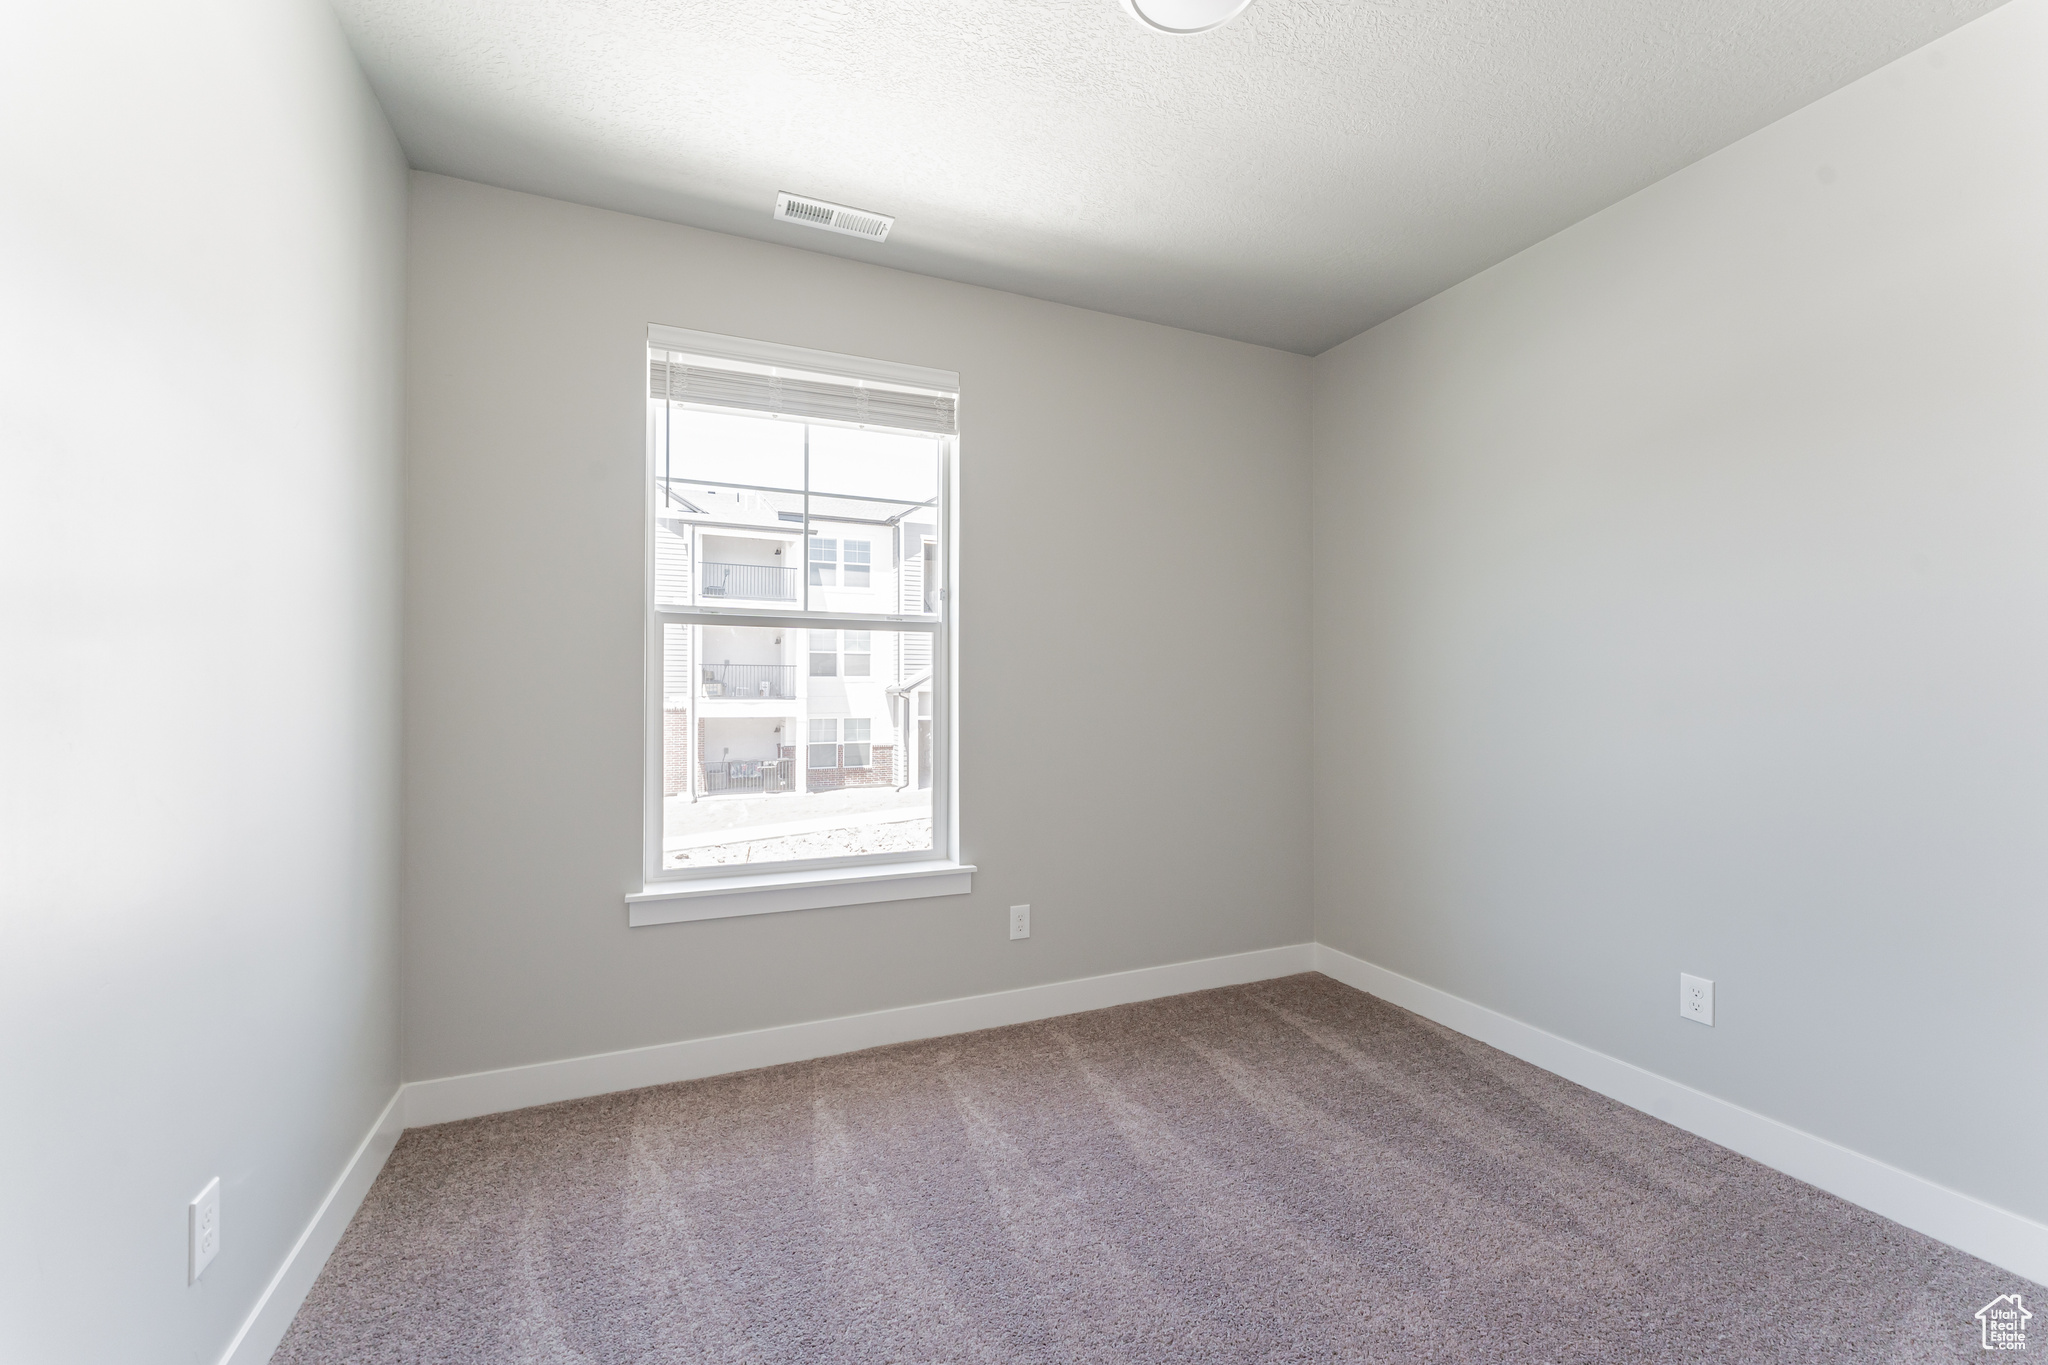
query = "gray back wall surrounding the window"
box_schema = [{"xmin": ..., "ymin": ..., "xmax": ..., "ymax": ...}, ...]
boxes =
[{"xmin": 403, "ymin": 174, "xmax": 1311, "ymax": 1078}]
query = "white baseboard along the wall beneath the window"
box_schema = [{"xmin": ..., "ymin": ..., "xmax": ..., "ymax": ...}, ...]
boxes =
[{"xmin": 406, "ymin": 943, "xmax": 1315, "ymax": 1128}]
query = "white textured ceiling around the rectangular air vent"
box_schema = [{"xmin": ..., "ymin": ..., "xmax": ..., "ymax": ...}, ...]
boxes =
[{"xmin": 336, "ymin": 0, "xmax": 1997, "ymax": 354}]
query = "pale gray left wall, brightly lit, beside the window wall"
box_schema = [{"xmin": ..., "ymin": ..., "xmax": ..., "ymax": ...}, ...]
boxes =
[{"xmin": 0, "ymin": 0, "xmax": 406, "ymax": 1365}]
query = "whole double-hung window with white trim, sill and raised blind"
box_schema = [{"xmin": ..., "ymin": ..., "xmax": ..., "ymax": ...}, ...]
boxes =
[{"xmin": 627, "ymin": 327, "xmax": 973, "ymax": 923}]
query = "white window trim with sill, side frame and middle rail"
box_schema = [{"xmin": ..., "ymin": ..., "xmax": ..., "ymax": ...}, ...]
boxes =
[{"xmin": 625, "ymin": 325, "xmax": 975, "ymax": 927}]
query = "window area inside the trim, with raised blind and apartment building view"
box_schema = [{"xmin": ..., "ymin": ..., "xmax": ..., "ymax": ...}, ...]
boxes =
[{"xmin": 649, "ymin": 356, "xmax": 948, "ymax": 876}]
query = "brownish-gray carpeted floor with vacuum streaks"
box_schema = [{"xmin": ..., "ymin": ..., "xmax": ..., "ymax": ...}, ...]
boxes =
[{"xmin": 274, "ymin": 976, "xmax": 2048, "ymax": 1365}]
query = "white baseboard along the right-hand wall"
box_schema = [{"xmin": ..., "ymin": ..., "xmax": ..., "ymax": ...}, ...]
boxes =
[{"xmin": 1313, "ymin": 943, "xmax": 2048, "ymax": 1285}]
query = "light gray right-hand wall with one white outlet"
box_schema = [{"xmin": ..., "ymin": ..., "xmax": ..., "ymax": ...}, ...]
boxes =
[{"xmin": 1313, "ymin": 0, "xmax": 2048, "ymax": 1220}]
